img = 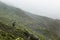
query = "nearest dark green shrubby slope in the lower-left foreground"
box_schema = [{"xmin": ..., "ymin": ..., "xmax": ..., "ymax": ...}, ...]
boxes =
[{"xmin": 0, "ymin": 22, "xmax": 45, "ymax": 40}]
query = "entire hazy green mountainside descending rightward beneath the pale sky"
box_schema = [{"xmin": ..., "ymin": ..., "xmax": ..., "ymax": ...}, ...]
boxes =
[{"xmin": 0, "ymin": 2, "xmax": 60, "ymax": 40}]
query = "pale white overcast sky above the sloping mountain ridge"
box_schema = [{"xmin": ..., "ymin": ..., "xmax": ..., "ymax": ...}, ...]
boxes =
[{"xmin": 0, "ymin": 0, "xmax": 60, "ymax": 19}]
